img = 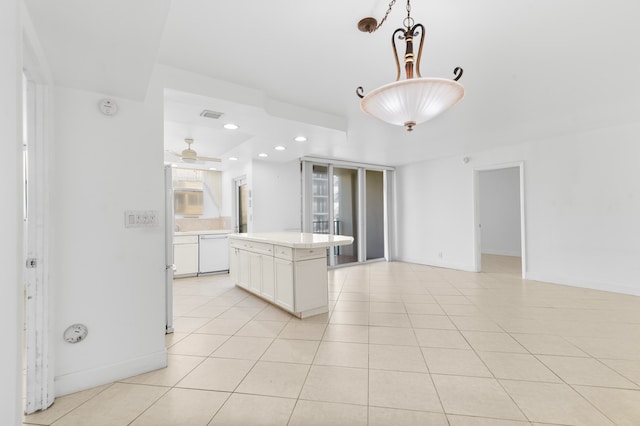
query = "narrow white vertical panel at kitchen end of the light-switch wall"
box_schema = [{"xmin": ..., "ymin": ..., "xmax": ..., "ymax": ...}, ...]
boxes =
[{"xmin": 164, "ymin": 166, "xmax": 176, "ymax": 333}]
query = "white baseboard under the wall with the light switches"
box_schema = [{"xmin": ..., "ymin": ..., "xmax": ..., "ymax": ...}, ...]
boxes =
[{"xmin": 54, "ymin": 350, "xmax": 167, "ymax": 397}]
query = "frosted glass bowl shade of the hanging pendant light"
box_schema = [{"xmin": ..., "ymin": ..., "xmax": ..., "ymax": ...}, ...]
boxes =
[{"xmin": 360, "ymin": 78, "xmax": 464, "ymax": 130}]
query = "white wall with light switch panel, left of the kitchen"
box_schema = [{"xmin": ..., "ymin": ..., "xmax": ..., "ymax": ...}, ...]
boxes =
[{"xmin": 51, "ymin": 84, "xmax": 166, "ymax": 395}]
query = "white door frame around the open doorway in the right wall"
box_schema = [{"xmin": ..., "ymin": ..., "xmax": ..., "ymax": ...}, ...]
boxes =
[{"xmin": 473, "ymin": 161, "xmax": 527, "ymax": 279}]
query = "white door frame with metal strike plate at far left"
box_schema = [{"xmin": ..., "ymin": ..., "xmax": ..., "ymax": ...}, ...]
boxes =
[{"xmin": 23, "ymin": 69, "xmax": 55, "ymax": 414}]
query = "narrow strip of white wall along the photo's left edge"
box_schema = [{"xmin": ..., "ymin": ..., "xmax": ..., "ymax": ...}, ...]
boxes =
[{"xmin": 0, "ymin": 0, "xmax": 23, "ymax": 425}]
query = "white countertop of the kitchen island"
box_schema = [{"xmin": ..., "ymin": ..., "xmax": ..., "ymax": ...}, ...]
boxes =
[{"xmin": 229, "ymin": 232, "xmax": 353, "ymax": 248}]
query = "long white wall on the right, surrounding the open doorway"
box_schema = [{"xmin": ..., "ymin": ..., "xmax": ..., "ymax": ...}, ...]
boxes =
[{"xmin": 396, "ymin": 124, "xmax": 640, "ymax": 295}]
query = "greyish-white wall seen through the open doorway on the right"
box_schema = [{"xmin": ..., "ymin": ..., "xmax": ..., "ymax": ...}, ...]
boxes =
[{"xmin": 478, "ymin": 167, "xmax": 522, "ymax": 256}]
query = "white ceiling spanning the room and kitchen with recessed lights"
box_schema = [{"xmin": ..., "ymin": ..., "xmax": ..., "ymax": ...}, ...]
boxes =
[{"xmin": 25, "ymin": 0, "xmax": 640, "ymax": 169}]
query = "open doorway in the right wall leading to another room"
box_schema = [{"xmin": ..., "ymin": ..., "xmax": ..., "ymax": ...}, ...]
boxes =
[{"xmin": 474, "ymin": 163, "xmax": 527, "ymax": 278}]
